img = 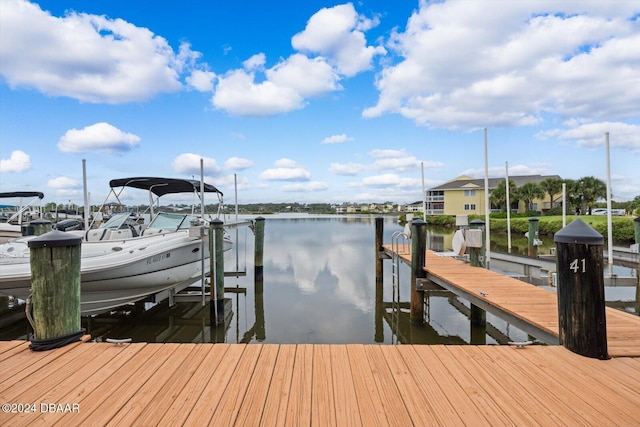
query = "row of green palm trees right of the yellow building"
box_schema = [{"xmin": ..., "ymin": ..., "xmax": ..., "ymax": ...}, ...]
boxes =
[{"xmin": 489, "ymin": 176, "xmax": 640, "ymax": 215}]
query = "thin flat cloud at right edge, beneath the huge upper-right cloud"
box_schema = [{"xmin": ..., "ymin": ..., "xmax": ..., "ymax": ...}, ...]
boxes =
[{"xmin": 536, "ymin": 122, "xmax": 640, "ymax": 152}]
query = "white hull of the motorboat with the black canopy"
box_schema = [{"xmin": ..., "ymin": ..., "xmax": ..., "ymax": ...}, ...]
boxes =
[{"xmin": 0, "ymin": 232, "xmax": 231, "ymax": 315}]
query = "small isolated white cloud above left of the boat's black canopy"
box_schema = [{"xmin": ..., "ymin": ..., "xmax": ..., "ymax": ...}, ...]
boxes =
[{"xmin": 58, "ymin": 122, "xmax": 140, "ymax": 154}]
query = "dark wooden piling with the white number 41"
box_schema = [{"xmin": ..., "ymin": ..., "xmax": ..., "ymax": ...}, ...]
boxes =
[{"xmin": 554, "ymin": 219, "xmax": 609, "ymax": 359}]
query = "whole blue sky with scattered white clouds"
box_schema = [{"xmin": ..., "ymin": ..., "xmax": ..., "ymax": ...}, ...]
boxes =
[{"xmin": 0, "ymin": 0, "xmax": 640, "ymax": 204}]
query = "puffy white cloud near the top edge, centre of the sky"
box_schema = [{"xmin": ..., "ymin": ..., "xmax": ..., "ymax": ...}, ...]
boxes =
[{"xmin": 291, "ymin": 3, "xmax": 386, "ymax": 77}]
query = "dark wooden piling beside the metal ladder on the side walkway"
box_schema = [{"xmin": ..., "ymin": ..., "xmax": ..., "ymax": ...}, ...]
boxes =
[{"xmin": 409, "ymin": 219, "xmax": 427, "ymax": 324}]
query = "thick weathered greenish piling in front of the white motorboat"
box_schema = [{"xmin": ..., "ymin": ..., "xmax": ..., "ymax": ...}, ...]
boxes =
[{"xmin": 29, "ymin": 230, "xmax": 82, "ymax": 350}]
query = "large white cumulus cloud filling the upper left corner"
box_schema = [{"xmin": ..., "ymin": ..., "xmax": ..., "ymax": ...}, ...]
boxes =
[{"xmin": 0, "ymin": 1, "xmax": 202, "ymax": 104}]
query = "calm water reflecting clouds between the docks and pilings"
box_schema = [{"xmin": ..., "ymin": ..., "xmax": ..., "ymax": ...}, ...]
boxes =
[{"xmin": 0, "ymin": 215, "xmax": 636, "ymax": 344}]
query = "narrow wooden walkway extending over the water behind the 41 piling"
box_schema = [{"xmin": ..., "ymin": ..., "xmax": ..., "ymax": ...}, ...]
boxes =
[{"xmin": 384, "ymin": 245, "xmax": 640, "ymax": 357}]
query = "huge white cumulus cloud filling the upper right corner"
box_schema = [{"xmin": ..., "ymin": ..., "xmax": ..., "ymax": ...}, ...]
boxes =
[{"xmin": 363, "ymin": 1, "xmax": 640, "ymax": 129}]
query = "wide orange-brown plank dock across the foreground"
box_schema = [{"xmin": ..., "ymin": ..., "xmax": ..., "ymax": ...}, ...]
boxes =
[{"xmin": 0, "ymin": 341, "xmax": 640, "ymax": 427}]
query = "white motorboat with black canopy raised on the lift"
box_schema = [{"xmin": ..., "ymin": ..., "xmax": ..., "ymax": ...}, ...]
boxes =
[{"xmin": 0, "ymin": 178, "xmax": 232, "ymax": 314}]
